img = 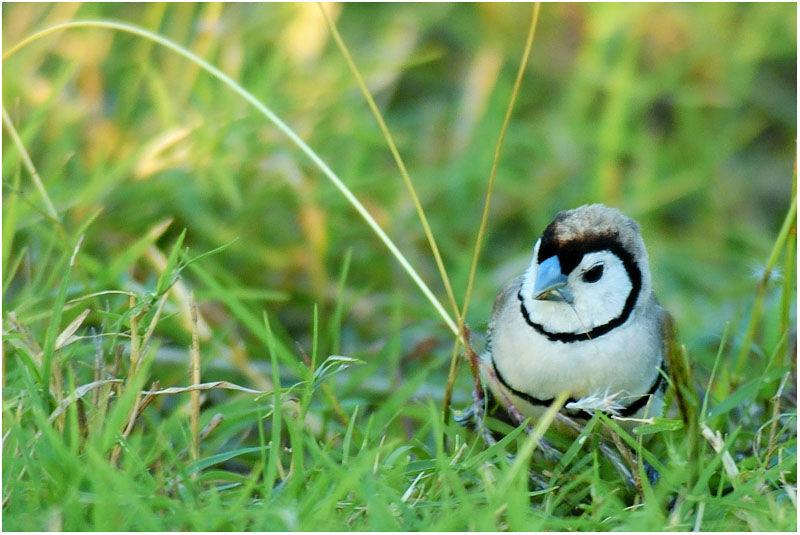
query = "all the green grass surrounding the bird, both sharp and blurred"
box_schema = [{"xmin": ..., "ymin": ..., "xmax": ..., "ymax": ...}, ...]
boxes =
[{"xmin": 2, "ymin": 4, "xmax": 797, "ymax": 531}]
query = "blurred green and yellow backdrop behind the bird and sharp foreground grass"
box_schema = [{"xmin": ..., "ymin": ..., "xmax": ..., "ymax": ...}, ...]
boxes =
[{"xmin": 2, "ymin": 3, "xmax": 797, "ymax": 529}]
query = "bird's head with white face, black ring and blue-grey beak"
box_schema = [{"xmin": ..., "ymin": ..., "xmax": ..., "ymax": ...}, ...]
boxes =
[{"xmin": 520, "ymin": 204, "xmax": 652, "ymax": 340}]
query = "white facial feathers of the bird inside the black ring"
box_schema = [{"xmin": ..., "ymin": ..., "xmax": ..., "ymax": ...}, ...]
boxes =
[{"xmin": 522, "ymin": 242, "xmax": 633, "ymax": 333}]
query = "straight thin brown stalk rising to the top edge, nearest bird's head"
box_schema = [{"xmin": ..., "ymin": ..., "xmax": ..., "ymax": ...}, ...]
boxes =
[{"xmin": 443, "ymin": 2, "xmax": 541, "ymax": 422}]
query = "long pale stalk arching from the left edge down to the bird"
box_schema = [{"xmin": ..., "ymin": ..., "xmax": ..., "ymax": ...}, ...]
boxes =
[{"xmin": 3, "ymin": 20, "xmax": 460, "ymax": 336}]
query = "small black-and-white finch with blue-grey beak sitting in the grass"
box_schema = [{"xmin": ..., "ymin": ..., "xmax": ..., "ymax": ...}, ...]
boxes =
[{"xmin": 483, "ymin": 204, "xmax": 672, "ymax": 418}]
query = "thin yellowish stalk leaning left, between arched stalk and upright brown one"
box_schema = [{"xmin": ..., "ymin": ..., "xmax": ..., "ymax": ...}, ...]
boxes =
[{"xmin": 317, "ymin": 2, "xmax": 461, "ymax": 323}]
